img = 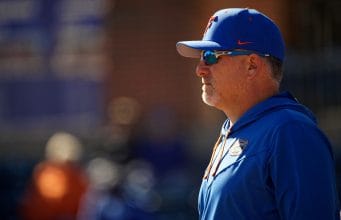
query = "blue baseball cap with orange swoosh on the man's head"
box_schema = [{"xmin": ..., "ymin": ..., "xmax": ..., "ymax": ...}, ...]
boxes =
[{"xmin": 176, "ymin": 8, "xmax": 285, "ymax": 61}]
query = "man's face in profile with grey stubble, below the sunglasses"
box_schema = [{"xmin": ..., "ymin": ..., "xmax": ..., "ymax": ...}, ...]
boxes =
[{"xmin": 196, "ymin": 56, "xmax": 247, "ymax": 109}]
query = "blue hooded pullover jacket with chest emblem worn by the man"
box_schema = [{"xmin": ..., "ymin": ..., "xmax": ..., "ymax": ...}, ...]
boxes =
[{"xmin": 198, "ymin": 92, "xmax": 340, "ymax": 220}]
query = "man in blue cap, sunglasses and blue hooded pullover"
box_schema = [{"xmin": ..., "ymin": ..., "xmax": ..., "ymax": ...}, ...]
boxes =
[{"xmin": 177, "ymin": 8, "xmax": 339, "ymax": 220}]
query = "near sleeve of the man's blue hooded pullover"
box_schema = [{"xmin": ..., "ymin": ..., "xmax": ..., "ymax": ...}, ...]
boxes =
[{"xmin": 269, "ymin": 122, "xmax": 340, "ymax": 220}]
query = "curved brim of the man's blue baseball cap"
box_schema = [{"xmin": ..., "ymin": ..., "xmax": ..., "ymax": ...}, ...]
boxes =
[{"xmin": 176, "ymin": 40, "xmax": 221, "ymax": 58}]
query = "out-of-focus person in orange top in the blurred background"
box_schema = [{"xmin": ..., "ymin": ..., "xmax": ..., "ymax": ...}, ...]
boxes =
[{"xmin": 20, "ymin": 133, "xmax": 88, "ymax": 220}]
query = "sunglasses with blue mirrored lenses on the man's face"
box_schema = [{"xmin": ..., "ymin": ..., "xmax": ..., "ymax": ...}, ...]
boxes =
[{"xmin": 201, "ymin": 50, "xmax": 270, "ymax": 65}]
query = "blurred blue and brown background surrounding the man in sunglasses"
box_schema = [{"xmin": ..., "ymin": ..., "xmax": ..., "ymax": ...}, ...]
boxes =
[{"xmin": 0, "ymin": 0, "xmax": 341, "ymax": 220}]
